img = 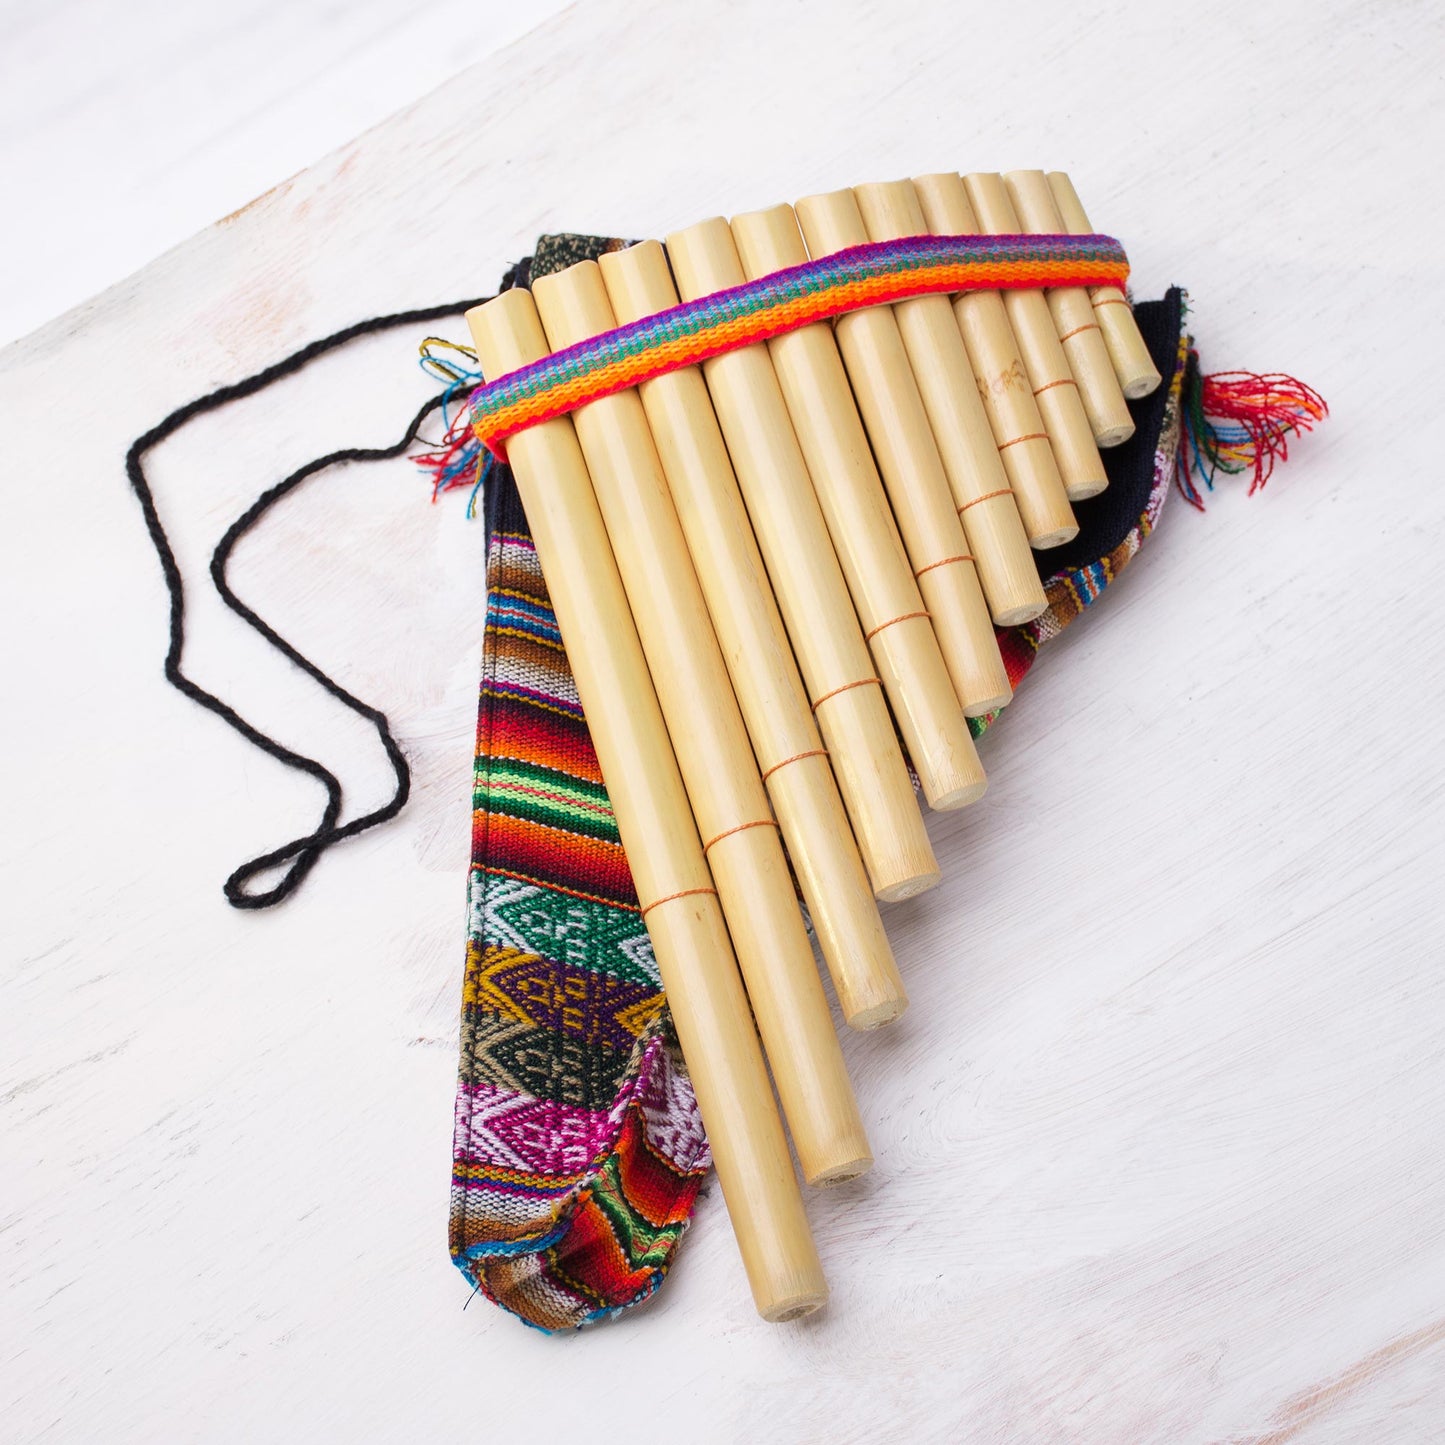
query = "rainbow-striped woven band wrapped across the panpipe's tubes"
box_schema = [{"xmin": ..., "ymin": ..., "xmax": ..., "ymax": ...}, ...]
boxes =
[{"xmin": 471, "ymin": 236, "xmax": 1129, "ymax": 461}]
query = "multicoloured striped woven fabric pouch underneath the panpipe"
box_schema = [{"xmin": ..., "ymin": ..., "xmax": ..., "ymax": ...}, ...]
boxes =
[{"xmin": 451, "ymin": 236, "xmax": 1188, "ymax": 1331}]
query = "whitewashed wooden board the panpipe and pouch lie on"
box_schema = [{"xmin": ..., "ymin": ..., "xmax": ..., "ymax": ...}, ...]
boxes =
[{"xmin": 0, "ymin": 0, "xmax": 1445, "ymax": 1445}]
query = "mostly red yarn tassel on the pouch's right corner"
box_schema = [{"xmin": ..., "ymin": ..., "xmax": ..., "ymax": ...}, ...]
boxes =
[{"xmin": 1179, "ymin": 351, "xmax": 1329, "ymax": 512}]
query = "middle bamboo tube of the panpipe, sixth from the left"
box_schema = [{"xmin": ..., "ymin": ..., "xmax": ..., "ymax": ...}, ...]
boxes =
[{"xmin": 795, "ymin": 191, "xmax": 1005, "ymax": 717}]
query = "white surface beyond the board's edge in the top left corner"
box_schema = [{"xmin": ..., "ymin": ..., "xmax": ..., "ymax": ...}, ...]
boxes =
[{"xmin": 0, "ymin": 0, "xmax": 565, "ymax": 342}]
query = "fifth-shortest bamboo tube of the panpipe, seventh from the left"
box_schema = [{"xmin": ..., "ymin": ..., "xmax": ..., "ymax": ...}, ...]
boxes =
[{"xmin": 843, "ymin": 182, "xmax": 1048, "ymax": 627}]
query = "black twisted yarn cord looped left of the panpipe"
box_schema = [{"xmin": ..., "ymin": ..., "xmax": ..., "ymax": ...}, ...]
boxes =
[{"xmin": 126, "ymin": 289, "xmax": 512, "ymax": 909}]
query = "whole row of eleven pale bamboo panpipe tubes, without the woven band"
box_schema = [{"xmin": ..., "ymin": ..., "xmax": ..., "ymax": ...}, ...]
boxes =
[{"xmin": 467, "ymin": 171, "xmax": 1160, "ymax": 1321}]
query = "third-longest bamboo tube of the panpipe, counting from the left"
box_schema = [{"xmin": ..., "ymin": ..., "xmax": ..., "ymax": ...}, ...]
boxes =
[{"xmin": 600, "ymin": 241, "xmax": 907, "ymax": 1029}]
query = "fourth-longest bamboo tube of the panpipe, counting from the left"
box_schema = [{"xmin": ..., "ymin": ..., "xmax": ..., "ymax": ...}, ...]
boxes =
[{"xmin": 668, "ymin": 218, "xmax": 939, "ymax": 902}]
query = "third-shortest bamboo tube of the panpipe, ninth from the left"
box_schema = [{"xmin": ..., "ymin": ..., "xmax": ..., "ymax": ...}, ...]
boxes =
[{"xmin": 947, "ymin": 175, "xmax": 1108, "ymax": 501}]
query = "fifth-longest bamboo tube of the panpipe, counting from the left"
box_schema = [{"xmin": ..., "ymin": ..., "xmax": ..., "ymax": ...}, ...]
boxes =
[{"xmin": 731, "ymin": 205, "xmax": 987, "ymax": 809}]
